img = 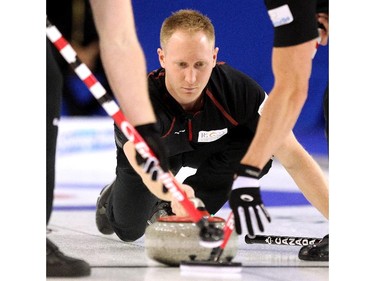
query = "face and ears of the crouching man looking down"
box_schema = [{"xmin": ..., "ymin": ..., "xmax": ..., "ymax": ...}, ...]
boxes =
[{"xmin": 158, "ymin": 31, "xmax": 219, "ymax": 110}]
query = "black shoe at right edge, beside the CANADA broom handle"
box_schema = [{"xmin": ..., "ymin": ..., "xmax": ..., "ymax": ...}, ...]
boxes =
[{"xmin": 298, "ymin": 234, "xmax": 329, "ymax": 261}]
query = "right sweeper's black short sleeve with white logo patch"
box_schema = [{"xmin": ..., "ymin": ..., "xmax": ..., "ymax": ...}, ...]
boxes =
[{"xmin": 264, "ymin": 0, "xmax": 319, "ymax": 47}]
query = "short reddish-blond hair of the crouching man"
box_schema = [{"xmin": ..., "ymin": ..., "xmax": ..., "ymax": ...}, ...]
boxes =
[{"xmin": 160, "ymin": 9, "xmax": 215, "ymax": 48}]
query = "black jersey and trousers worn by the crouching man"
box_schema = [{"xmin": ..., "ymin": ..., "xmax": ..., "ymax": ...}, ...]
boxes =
[{"xmin": 111, "ymin": 63, "xmax": 272, "ymax": 225}]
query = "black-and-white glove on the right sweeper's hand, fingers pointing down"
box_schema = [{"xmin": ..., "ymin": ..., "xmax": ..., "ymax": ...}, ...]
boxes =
[{"xmin": 229, "ymin": 164, "xmax": 271, "ymax": 237}]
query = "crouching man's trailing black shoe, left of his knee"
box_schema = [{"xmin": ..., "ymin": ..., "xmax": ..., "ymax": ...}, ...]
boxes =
[{"xmin": 95, "ymin": 184, "xmax": 114, "ymax": 235}]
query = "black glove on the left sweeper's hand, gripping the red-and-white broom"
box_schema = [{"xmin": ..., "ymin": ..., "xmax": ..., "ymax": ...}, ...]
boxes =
[{"xmin": 134, "ymin": 123, "xmax": 168, "ymax": 182}]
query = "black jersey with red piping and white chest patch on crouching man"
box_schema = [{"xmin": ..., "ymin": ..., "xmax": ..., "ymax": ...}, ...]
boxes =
[{"xmin": 148, "ymin": 63, "xmax": 266, "ymax": 156}]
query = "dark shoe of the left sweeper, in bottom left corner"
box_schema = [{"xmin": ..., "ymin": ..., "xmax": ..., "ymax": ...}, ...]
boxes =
[{"xmin": 46, "ymin": 238, "xmax": 91, "ymax": 277}]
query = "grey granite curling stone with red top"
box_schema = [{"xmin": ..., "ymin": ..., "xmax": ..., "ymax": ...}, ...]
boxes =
[{"xmin": 145, "ymin": 198, "xmax": 238, "ymax": 266}]
